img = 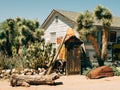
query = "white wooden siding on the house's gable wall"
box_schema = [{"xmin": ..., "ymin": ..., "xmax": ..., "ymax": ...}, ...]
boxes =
[{"xmin": 44, "ymin": 14, "xmax": 73, "ymax": 45}]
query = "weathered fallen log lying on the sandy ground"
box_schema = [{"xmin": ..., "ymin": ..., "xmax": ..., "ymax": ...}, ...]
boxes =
[{"xmin": 10, "ymin": 74, "xmax": 59, "ymax": 87}]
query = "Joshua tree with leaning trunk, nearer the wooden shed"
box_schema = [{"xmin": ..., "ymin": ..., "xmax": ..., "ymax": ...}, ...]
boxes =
[{"xmin": 77, "ymin": 10, "xmax": 101, "ymax": 65}]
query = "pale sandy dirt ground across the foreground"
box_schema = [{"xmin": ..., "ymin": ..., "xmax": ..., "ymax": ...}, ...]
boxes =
[{"xmin": 0, "ymin": 75, "xmax": 120, "ymax": 90}]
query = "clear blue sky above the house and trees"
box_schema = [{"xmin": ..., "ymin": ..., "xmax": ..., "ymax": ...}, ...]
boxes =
[{"xmin": 0, "ymin": 0, "xmax": 120, "ymax": 24}]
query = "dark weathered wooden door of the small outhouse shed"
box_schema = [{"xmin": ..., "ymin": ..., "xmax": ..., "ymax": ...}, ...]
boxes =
[{"xmin": 66, "ymin": 47, "xmax": 81, "ymax": 75}]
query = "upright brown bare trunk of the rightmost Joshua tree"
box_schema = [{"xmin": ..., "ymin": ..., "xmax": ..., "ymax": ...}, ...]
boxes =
[{"xmin": 101, "ymin": 27, "xmax": 108, "ymax": 61}]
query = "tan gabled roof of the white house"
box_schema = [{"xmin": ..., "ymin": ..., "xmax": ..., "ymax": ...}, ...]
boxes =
[{"xmin": 41, "ymin": 9, "xmax": 120, "ymax": 28}]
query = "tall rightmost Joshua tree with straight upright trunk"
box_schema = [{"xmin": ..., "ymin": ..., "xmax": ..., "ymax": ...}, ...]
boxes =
[{"xmin": 94, "ymin": 5, "xmax": 112, "ymax": 65}]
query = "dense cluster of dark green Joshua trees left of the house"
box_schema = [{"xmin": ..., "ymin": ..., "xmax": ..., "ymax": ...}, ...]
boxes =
[{"xmin": 0, "ymin": 17, "xmax": 43, "ymax": 56}]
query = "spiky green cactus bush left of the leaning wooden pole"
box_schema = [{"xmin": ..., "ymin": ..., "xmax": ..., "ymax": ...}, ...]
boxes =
[{"xmin": 23, "ymin": 41, "xmax": 55, "ymax": 69}]
